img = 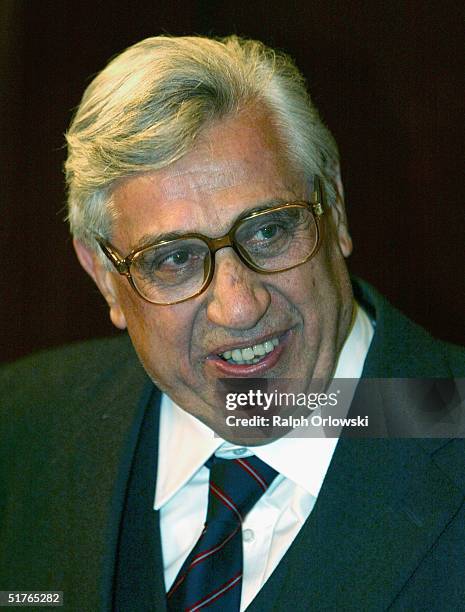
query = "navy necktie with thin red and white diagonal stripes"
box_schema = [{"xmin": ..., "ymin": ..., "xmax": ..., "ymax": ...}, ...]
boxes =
[{"xmin": 167, "ymin": 456, "xmax": 277, "ymax": 612}]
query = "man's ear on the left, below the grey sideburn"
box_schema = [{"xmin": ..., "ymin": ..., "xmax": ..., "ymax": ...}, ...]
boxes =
[{"xmin": 73, "ymin": 239, "xmax": 127, "ymax": 329}]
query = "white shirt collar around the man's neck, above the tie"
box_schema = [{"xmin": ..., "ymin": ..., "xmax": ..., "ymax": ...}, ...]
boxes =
[{"xmin": 155, "ymin": 303, "xmax": 373, "ymax": 510}]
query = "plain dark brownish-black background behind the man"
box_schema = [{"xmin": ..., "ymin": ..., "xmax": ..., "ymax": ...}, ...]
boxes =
[{"xmin": 0, "ymin": 0, "xmax": 465, "ymax": 360}]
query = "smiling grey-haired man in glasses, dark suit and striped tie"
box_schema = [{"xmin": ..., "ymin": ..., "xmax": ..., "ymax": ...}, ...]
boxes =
[{"xmin": 0, "ymin": 37, "xmax": 465, "ymax": 611}]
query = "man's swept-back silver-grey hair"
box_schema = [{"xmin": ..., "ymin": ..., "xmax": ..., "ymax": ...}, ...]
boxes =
[{"xmin": 65, "ymin": 36, "xmax": 338, "ymax": 248}]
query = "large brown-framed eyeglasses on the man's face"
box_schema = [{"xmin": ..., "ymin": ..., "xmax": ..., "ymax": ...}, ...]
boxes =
[{"xmin": 96, "ymin": 176, "xmax": 324, "ymax": 306}]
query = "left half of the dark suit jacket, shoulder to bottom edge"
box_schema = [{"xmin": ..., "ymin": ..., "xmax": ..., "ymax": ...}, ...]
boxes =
[{"xmin": 0, "ymin": 337, "xmax": 158, "ymax": 610}]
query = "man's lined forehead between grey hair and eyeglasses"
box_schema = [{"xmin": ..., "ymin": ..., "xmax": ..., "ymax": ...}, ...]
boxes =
[{"xmin": 112, "ymin": 111, "xmax": 304, "ymax": 248}]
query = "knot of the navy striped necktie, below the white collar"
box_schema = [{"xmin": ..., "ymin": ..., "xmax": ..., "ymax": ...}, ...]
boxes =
[{"xmin": 207, "ymin": 456, "xmax": 277, "ymax": 524}]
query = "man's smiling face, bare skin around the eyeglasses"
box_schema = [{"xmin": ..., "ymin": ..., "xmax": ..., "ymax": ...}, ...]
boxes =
[{"xmin": 79, "ymin": 111, "xmax": 352, "ymax": 436}]
